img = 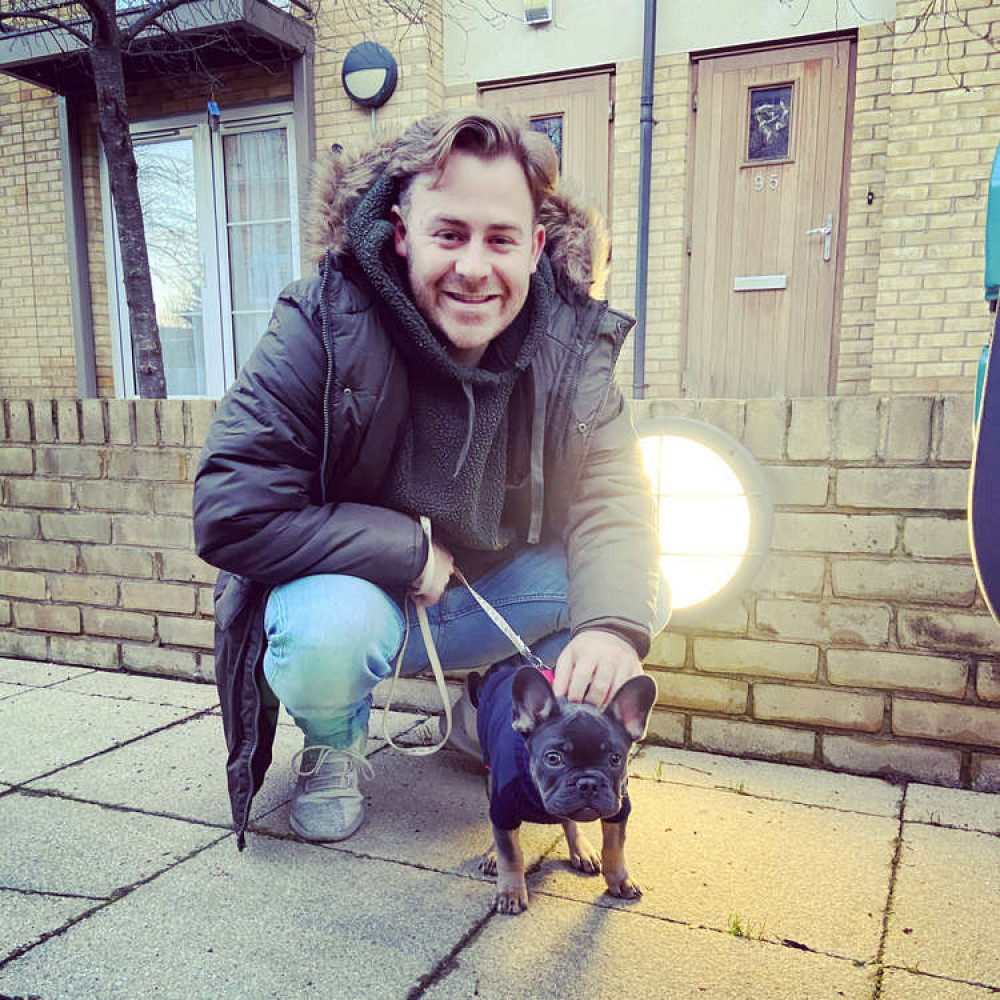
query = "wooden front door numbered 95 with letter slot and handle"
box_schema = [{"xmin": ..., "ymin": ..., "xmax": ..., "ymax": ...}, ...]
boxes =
[{"xmin": 684, "ymin": 41, "xmax": 852, "ymax": 398}]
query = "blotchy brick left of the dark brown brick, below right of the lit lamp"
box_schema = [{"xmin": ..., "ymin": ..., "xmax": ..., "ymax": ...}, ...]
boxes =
[{"xmin": 757, "ymin": 598, "xmax": 889, "ymax": 646}]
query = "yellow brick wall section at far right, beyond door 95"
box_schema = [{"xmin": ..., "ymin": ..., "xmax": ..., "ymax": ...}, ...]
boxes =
[{"xmin": 870, "ymin": 0, "xmax": 1000, "ymax": 392}]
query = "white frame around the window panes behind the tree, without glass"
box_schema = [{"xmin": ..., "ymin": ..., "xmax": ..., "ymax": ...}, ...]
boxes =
[{"xmin": 100, "ymin": 101, "xmax": 302, "ymax": 399}]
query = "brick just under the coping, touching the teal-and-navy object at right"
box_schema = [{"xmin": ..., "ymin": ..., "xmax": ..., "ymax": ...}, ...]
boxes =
[{"xmin": 837, "ymin": 469, "xmax": 969, "ymax": 511}]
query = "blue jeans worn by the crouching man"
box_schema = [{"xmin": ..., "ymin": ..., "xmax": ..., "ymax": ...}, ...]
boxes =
[{"xmin": 264, "ymin": 544, "xmax": 669, "ymax": 749}]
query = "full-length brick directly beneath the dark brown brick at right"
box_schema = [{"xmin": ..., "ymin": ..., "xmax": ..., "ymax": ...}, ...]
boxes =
[{"xmin": 826, "ymin": 649, "xmax": 969, "ymax": 698}]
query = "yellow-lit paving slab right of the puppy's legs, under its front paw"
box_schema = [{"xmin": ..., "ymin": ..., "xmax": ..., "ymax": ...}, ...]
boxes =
[{"xmin": 528, "ymin": 781, "xmax": 898, "ymax": 961}]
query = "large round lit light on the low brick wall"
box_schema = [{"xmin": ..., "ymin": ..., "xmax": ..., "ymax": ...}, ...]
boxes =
[{"xmin": 639, "ymin": 417, "xmax": 772, "ymax": 624}]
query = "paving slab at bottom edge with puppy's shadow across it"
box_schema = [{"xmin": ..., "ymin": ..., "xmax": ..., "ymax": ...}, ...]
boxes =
[{"xmin": 424, "ymin": 897, "xmax": 874, "ymax": 1000}]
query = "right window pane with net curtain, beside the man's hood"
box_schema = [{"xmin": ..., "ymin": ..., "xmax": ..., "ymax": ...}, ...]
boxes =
[{"xmin": 223, "ymin": 128, "xmax": 295, "ymax": 370}]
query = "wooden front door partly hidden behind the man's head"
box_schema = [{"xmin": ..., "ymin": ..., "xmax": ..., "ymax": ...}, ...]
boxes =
[{"xmin": 479, "ymin": 70, "xmax": 614, "ymax": 219}]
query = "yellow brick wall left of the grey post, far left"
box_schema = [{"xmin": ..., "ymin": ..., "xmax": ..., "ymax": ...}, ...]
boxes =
[{"xmin": 0, "ymin": 77, "xmax": 76, "ymax": 395}]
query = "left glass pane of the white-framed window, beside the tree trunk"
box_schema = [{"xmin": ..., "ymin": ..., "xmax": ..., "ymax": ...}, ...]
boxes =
[{"xmin": 135, "ymin": 139, "xmax": 206, "ymax": 396}]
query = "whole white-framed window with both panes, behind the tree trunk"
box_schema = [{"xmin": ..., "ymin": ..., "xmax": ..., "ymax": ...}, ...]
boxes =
[{"xmin": 104, "ymin": 103, "xmax": 299, "ymax": 397}]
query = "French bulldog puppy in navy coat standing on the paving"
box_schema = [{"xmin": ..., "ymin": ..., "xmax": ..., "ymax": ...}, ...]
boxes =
[{"xmin": 469, "ymin": 664, "xmax": 656, "ymax": 914}]
